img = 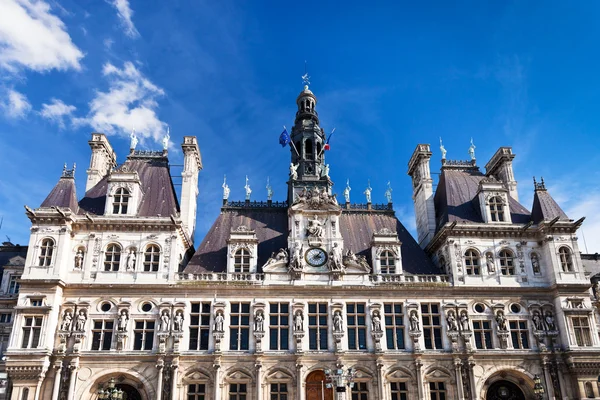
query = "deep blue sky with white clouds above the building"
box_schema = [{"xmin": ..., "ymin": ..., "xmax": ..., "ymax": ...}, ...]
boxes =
[{"xmin": 0, "ymin": 0, "xmax": 600, "ymax": 252}]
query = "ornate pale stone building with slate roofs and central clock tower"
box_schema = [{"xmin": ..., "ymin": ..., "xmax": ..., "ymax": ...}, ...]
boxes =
[{"xmin": 3, "ymin": 83, "xmax": 600, "ymax": 400}]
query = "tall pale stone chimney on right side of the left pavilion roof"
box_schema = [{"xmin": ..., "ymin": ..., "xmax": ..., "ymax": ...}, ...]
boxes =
[{"xmin": 181, "ymin": 136, "xmax": 202, "ymax": 243}]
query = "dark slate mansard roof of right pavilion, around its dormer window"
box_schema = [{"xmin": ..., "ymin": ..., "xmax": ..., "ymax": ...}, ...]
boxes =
[{"xmin": 434, "ymin": 166, "xmax": 531, "ymax": 230}]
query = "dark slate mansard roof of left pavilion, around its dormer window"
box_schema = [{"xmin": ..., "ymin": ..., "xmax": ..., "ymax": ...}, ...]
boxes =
[{"xmin": 79, "ymin": 151, "xmax": 179, "ymax": 217}]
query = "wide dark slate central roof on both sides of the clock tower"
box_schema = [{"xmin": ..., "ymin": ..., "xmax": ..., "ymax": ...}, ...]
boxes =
[{"xmin": 183, "ymin": 206, "xmax": 440, "ymax": 274}]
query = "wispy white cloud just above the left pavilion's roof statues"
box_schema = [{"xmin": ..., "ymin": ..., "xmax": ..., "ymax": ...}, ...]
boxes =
[{"xmin": 74, "ymin": 62, "xmax": 167, "ymax": 142}]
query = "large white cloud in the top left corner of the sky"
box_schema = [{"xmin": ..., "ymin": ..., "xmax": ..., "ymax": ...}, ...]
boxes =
[{"xmin": 0, "ymin": 0, "xmax": 83, "ymax": 73}]
